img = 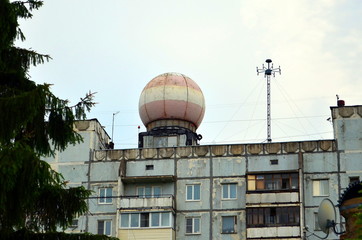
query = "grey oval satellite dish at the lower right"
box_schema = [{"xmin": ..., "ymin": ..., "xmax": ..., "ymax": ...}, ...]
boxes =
[{"xmin": 318, "ymin": 198, "xmax": 336, "ymax": 234}]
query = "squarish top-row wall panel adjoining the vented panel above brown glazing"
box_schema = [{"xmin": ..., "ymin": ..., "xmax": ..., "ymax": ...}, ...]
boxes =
[{"xmin": 212, "ymin": 157, "xmax": 246, "ymax": 176}]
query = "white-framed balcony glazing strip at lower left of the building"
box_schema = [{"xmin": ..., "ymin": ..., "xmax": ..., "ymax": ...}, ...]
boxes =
[{"xmin": 120, "ymin": 212, "xmax": 171, "ymax": 228}]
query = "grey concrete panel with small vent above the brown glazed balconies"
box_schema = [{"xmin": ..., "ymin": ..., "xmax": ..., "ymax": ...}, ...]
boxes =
[{"xmin": 248, "ymin": 154, "xmax": 298, "ymax": 172}]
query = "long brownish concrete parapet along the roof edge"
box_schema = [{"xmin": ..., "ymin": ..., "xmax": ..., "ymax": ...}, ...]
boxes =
[{"xmin": 92, "ymin": 140, "xmax": 336, "ymax": 161}]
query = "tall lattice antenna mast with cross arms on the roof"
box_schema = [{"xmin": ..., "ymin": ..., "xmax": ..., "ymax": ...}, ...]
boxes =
[{"xmin": 256, "ymin": 59, "xmax": 281, "ymax": 142}]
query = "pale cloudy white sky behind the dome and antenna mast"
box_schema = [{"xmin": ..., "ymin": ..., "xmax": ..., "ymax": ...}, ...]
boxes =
[{"xmin": 20, "ymin": 0, "xmax": 362, "ymax": 148}]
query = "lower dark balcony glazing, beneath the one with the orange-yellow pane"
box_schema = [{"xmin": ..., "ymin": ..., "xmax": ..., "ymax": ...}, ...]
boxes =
[{"xmin": 246, "ymin": 207, "xmax": 299, "ymax": 227}]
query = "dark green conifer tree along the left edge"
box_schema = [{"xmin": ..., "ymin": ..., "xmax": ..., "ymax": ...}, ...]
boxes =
[{"xmin": 0, "ymin": 0, "xmax": 94, "ymax": 236}]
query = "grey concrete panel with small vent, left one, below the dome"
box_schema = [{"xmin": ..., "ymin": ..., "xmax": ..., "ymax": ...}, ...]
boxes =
[{"xmin": 126, "ymin": 159, "xmax": 175, "ymax": 177}]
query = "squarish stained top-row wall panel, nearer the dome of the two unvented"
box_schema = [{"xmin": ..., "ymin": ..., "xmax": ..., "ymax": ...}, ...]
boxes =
[{"xmin": 177, "ymin": 158, "xmax": 210, "ymax": 178}]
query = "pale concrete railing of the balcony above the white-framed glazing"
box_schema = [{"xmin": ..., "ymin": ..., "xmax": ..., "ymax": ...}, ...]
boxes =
[{"xmin": 120, "ymin": 195, "xmax": 175, "ymax": 210}]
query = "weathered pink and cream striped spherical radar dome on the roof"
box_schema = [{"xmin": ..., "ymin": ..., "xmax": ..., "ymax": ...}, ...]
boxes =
[{"xmin": 139, "ymin": 73, "xmax": 205, "ymax": 129}]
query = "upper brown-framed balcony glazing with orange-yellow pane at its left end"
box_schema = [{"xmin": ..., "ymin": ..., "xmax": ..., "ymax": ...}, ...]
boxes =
[{"xmin": 247, "ymin": 173, "xmax": 299, "ymax": 191}]
